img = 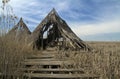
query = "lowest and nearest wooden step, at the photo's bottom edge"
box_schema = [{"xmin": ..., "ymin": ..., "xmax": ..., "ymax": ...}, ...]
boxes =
[{"xmin": 24, "ymin": 73, "xmax": 99, "ymax": 79}]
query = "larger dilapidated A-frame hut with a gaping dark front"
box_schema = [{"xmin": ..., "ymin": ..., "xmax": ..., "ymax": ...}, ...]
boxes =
[{"xmin": 32, "ymin": 9, "xmax": 91, "ymax": 50}]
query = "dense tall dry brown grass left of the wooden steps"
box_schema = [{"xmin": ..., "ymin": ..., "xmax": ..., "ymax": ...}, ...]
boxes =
[{"xmin": 0, "ymin": 35, "xmax": 34, "ymax": 79}]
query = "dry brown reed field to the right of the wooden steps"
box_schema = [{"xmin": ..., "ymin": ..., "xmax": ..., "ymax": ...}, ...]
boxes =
[{"xmin": 59, "ymin": 42, "xmax": 120, "ymax": 79}]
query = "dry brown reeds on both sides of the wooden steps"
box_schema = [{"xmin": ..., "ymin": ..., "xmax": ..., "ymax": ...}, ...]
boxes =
[{"xmin": 0, "ymin": 36, "xmax": 120, "ymax": 79}]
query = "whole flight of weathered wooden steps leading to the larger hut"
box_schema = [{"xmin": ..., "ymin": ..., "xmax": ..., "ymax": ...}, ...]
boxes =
[{"xmin": 23, "ymin": 51, "xmax": 99, "ymax": 79}]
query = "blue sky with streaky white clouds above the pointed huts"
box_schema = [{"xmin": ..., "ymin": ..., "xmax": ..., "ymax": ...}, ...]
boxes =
[{"xmin": 0, "ymin": 0, "xmax": 120, "ymax": 41}]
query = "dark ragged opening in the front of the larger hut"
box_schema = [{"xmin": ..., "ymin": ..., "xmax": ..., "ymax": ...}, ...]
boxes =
[{"xmin": 38, "ymin": 23, "xmax": 61, "ymax": 49}]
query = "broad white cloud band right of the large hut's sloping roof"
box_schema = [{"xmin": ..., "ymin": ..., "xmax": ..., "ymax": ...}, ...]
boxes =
[{"xmin": 70, "ymin": 21, "xmax": 120, "ymax": 36}]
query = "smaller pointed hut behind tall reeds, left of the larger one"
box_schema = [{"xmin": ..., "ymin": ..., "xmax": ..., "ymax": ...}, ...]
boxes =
[{"xmin": 8, "ymin": 18, "xmax": 31, "ymax": 42}]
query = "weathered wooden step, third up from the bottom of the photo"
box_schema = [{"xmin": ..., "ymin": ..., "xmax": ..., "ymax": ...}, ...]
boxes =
[{"xmin": 23, "ymin": 60, "xmax": 73, "ymax": 65}]
